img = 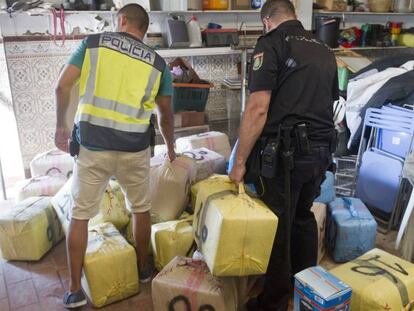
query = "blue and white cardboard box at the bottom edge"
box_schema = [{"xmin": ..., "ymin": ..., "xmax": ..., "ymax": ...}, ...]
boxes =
[{"xmin": 294, "ymin": 266, "xmax": 352, "ymax": 311}]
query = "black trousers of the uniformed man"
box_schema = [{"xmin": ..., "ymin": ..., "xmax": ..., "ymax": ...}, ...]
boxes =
[{"xmin": 255, "ymin": 145, "xmax": 332, "ymax": 311}]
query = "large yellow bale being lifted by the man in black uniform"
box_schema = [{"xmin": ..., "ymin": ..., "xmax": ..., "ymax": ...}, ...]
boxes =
[{"xmin": 194, "ymin": 180, "xmax": 278, "ymax": 276}]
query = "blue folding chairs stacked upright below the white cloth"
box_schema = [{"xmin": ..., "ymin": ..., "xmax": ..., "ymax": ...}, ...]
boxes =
[{"xmin": 355, "ymin": 105, "xmax": 414, "ymax": 230}]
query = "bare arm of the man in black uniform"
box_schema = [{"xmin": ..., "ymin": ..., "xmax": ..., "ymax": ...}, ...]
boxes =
[{"xmin": 236, "ymin": 91, "xmax": 272, "ymax": 166}]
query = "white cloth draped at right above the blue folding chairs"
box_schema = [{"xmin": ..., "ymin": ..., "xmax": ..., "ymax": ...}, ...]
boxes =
[{"xmin": 346, "ymin": 61, "xmax": 414, "ymax": 148}]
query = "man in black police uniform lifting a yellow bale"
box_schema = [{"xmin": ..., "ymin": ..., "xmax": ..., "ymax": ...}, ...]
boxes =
[{"xmin": 230, "ymin": 0, "xmax": 339, "ymax": 311}]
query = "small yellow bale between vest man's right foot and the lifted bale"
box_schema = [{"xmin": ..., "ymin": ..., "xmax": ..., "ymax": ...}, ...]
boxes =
[{"xmin": 151, "ymin": 216, "xmax": 194, "ymax": 271}]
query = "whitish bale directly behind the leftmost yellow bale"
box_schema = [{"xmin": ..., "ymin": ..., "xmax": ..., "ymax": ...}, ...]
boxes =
[{"xmin": 16, "ymin": 173, "xmax": 67, "ymax": 202}]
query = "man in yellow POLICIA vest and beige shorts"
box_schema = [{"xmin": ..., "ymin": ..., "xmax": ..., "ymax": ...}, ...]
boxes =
[{"xmin": 55, "ymin": 4, "xmax": 175, "ymax": 308}]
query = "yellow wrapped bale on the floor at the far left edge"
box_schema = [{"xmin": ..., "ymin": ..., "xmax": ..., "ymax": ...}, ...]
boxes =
[{"xmin": 0, "ymin": 197, "xmax": 63, "ymax": 260}]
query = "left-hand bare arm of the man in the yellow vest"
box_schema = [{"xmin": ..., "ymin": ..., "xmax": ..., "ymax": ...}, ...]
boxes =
[{"xmin": 55, "ymin": 65, "xmax": 81, "ymax": 128}]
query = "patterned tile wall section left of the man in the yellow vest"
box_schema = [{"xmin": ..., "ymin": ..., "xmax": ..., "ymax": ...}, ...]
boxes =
[{"xmin": 5, "ymin": 40, "xmax": 80, "ymax": 168}]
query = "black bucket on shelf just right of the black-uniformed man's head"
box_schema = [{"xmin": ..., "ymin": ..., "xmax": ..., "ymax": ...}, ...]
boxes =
[{"xmin": 315, "ymin": 16, "xmax": 341, "ymax": 48}]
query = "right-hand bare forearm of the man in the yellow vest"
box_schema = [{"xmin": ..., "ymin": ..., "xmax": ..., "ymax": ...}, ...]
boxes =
[{"xmin": 155, "ymin": 96, "xmax": 174, "ymax": 156}]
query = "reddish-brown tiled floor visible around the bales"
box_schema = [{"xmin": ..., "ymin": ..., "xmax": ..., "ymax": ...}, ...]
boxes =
[{"xmin": 0, "ymin": 232, "xmax": 398, "ymax": 311}]
